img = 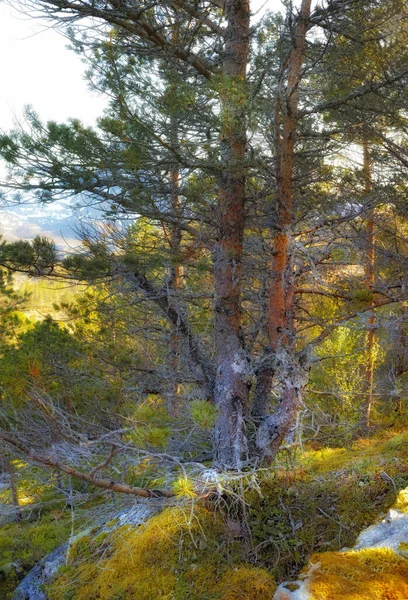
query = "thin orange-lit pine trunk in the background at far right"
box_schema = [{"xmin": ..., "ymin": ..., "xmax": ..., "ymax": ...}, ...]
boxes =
[{"xmin": 361, "ymin": 140, "xmax": 375, "ymax": 431}]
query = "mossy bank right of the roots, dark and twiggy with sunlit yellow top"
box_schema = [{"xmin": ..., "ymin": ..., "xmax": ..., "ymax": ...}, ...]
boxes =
[{"xmin": 245, "ymin": 431, "xmax": 408, "ymax": 582}]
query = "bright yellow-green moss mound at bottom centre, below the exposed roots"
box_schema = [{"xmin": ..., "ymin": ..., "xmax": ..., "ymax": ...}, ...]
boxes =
[{"xmin": 47, "ymin": 508, "xmax": 276, "ymax": 600}]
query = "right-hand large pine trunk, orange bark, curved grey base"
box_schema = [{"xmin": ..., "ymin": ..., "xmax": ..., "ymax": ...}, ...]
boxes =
[{"xmin": 253, "ymin": 0, "xmax": 311, "ymax": 456}]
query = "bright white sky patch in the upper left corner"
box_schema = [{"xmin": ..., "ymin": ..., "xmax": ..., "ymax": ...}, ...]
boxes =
[{"xmin": 0, "ymin": 0, "xmax": 105, "ymax": 130}]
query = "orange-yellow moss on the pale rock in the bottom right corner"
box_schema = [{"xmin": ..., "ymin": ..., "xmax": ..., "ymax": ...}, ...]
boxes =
[{"xmin": 309, "ymin": 548, "xmax": 408, "ymax": 600}]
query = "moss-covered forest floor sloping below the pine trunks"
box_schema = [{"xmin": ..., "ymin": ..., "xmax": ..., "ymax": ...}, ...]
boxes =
[{"xmin": 0, "ymin": 429, "xmax": 408, "ymax": 600}]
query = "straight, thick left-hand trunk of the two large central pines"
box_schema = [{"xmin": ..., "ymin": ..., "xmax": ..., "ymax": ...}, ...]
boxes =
[{"xmin": 214, "ymin": 0, "xmax": 249, "ymax": 469}]
